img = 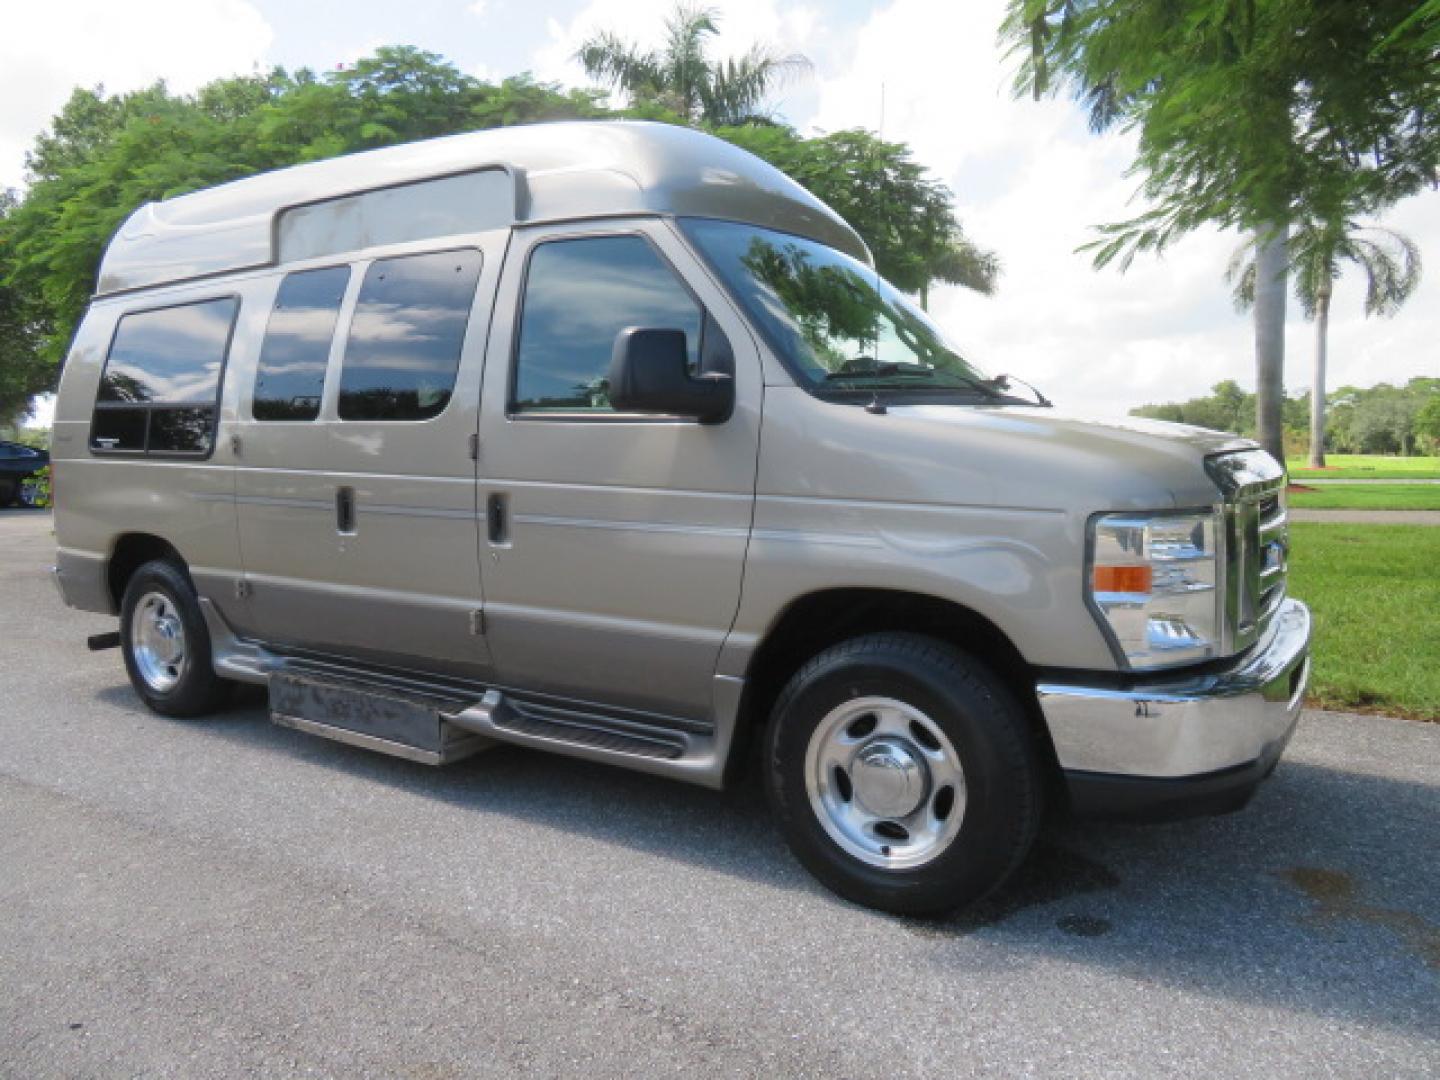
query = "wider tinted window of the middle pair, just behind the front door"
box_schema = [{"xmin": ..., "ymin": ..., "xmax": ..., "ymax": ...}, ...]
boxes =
[{"xmin": 340, "ymin": 249, "xmax": 480, "ymax": 420}]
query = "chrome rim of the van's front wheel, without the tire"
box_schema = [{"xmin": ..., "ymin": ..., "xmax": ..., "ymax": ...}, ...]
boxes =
[{"xmin": 805, "ymin": 697, "xmax": 965, "ymax": 870}]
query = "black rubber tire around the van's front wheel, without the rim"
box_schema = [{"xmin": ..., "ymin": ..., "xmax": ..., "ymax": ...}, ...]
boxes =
[{"xmin": 765, "ymin": 632, "xmax": 1043, "ymax": 916}]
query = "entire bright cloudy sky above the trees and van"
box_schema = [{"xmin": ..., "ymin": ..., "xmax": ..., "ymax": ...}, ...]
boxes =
[{"xmin": 0, "ymin": 0, "xmax": 1440, "ymax": 416}]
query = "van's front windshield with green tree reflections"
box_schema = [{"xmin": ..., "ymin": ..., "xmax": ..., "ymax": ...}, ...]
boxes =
[{"xmin": 681, "ymin": 217, "xmax": 1004, "ymax": 399}]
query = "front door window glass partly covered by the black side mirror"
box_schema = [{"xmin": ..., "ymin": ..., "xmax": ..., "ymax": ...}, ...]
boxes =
[{"xmin": 514, "ymin": 236, "xmax": 703, "ymax": 412}]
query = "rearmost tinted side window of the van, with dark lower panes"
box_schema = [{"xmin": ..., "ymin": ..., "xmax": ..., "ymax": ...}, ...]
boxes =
[{"xmin": 91, "ymin": 297, "xmax": 239, "ymax": 456}]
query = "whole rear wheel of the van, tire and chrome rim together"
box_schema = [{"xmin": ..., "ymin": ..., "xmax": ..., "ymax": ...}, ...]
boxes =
[{"xmin": 120, "ymin": 560, "xmax": 229, "ymax": 716}]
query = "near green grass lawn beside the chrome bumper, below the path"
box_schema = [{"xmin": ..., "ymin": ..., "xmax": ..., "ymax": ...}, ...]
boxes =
[{"xmin": 1290, "ymin": 523, "xmax": 1440, "ymax": 720}]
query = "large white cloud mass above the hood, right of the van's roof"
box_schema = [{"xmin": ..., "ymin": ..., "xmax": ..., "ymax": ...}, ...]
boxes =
[{"xmin": 814, "ymin": 0, "xmax": 1440, "ymax": 415}]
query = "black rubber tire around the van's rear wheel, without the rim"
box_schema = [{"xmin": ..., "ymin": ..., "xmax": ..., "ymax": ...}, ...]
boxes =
[{"xmin": 120, "ymin": 560, "xmax": 232, "ymax": 717}]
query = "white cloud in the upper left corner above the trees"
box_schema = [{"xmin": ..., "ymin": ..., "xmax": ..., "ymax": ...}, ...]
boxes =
[{"xmin": 0, "ymin": 0, "xmax": 274, "ymax": 187}]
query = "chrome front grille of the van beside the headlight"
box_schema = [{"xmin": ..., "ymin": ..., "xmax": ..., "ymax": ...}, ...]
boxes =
[{"xmin": 1207, "ymin": 451, "xmax": 1290, "ymax": 654}]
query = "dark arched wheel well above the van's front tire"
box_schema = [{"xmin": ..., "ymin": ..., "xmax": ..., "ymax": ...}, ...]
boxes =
[{"xmin": 730, "ymin": 589, "xmax": 1060, "ymax": 783}]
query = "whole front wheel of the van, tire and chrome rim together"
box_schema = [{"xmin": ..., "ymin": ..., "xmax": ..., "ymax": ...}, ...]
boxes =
[{"xmin": 766, "ymin": 634, "xmax": 1041, "ymax": 914}]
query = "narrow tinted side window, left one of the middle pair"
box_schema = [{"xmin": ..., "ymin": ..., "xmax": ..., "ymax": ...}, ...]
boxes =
[{"xmin": 251, "ymin": 266, "xmax": 350, "ymax": 420}]
